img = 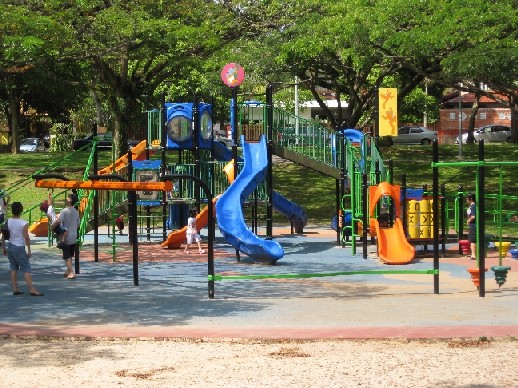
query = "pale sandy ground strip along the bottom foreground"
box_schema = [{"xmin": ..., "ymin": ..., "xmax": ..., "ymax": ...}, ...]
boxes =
[{"xmin": 0, "ymin": 337, "xmax": 518, "ymax": 388}]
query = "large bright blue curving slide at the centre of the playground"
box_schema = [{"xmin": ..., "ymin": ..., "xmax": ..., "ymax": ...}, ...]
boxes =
[{"xmin": 216, "ymin": 136, "xmax": 284, "ymax": 264}]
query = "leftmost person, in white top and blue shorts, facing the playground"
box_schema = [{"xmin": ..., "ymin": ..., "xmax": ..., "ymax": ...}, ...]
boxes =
[{"xmin": 2, "ymin": 202, "xmax": 43, "ymax": 296}]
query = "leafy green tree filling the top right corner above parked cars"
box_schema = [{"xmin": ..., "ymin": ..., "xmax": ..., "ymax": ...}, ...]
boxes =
[{"xmin": 374, "ymin": 0, "xmax": 518, "ymax": 142}]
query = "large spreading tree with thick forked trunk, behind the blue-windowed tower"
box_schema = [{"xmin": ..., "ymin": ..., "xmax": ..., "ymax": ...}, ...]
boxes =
[{"xmin": 36, "ymin": 0, "xmax": 238, "ymax": 153}]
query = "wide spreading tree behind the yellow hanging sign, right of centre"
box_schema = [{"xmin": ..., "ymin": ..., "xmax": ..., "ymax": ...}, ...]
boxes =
[{"xmin": 220, "ymin": 0, "xmax": 434, "ymax": 128}]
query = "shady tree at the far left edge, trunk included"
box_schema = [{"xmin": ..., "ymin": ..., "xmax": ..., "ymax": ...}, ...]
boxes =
[{"xmin": 0, "ymin": 2, "xmax": 82, "ymax": 153}]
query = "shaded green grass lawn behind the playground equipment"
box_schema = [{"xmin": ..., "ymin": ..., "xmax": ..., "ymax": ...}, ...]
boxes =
[{"xmin": 0, "ymin": 144, "xmax": 518, "ymax": 235}]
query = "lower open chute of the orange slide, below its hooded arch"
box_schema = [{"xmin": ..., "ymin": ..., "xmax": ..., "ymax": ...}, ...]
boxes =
[{"xmin": 371, "ymin": 218, "xmax": 415, "ymax": 264}]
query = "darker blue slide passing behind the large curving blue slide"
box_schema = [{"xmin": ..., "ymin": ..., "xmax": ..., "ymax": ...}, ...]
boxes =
[{"xmin": 214, "ymin": 142, "xmax": 308, "ymax": 233}]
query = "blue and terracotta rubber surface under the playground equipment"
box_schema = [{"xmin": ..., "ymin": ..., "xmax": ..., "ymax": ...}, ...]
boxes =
[{"xmin": 0, "ymin": 226, "xmax": 518, "ymax": 339}]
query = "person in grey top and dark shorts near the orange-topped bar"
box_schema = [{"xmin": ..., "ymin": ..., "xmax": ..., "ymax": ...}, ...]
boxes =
[{"xmin": 51, "ymin": 194, "xmax": 79, "ymax": 279}]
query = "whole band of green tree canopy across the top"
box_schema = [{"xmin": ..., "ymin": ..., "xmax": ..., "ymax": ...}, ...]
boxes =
[{"xmin": 0, "ymin": 0, "xmax": 518, "ymax": 152}]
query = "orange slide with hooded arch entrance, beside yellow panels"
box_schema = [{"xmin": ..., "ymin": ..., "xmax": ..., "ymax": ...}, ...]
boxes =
[{"xmin": 370, "ymin": 182, "xmax": 415, "ymax": 264}]
